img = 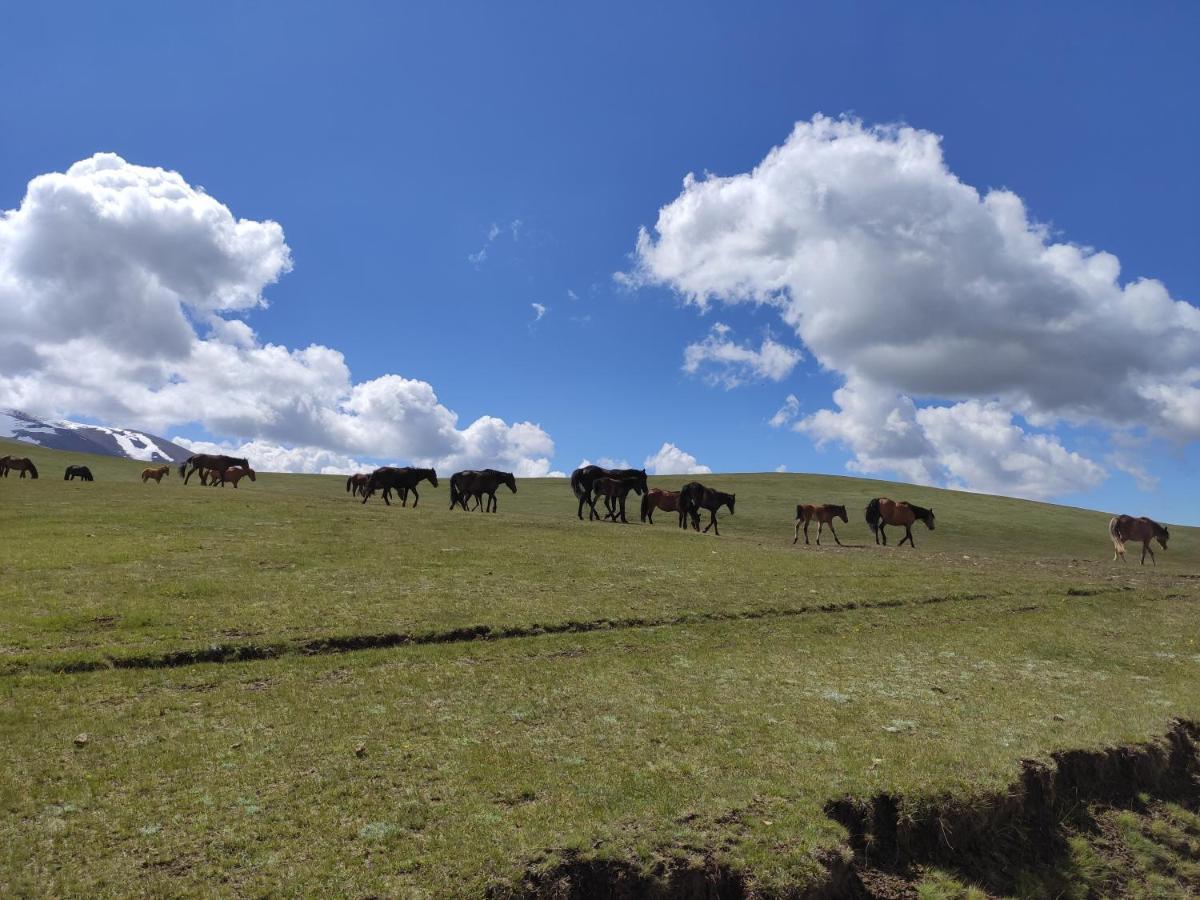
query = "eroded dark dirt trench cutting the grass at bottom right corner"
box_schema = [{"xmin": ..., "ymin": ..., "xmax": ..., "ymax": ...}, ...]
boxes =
[{"xmin": 491, "ymin": 721, "xmax": 1200, "ymax": 900}]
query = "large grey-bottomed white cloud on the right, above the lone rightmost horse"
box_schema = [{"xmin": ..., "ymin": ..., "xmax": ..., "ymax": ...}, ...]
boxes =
[{"xmin": 626, "ymin": 115, "xmax": 1200, "ymax": 494}]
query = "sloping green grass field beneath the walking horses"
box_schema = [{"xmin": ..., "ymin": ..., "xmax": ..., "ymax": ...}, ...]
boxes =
[{"xmin": 0, "ymin": 442, "xmax": 1200, "ymax": 896}]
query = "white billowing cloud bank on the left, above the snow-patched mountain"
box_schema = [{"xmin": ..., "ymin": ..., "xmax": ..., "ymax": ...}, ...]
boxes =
[{"xmin": 0, "ymin": 154, "xmax": 554, "ymax": 475}]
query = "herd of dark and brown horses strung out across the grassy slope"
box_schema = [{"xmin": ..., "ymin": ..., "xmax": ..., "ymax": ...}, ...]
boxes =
[{"xmin": 0, "ymin": 454, "xmax": 1171, "ymax": 565}]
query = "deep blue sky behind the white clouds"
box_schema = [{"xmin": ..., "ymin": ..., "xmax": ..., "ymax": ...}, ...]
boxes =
[{"xmin": 0, "ymin": 2, "xmax": 1200, "ymax": 522}]
